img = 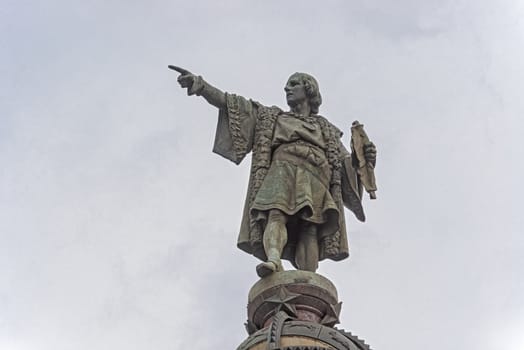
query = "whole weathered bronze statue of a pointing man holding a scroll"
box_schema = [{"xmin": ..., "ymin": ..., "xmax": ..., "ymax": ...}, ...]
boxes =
[{"xmin": 169, "ymin": 66, "xmax": 376, "ymax": 277}]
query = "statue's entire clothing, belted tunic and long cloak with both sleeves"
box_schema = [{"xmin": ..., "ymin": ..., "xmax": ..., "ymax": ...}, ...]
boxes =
[{"xmin": 213, "ymin": 94, "xmax": 365, "ymax": 264}]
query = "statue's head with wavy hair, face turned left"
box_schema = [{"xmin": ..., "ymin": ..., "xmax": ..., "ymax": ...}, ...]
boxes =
[{"xmin": 284, "ymin": 73, "xmax": 322, "ymax": 114}]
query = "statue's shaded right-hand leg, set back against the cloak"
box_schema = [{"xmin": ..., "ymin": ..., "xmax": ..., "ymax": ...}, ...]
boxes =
[{"xmin": 295, "ymin": 222, "xmax": 318, "ymax": 272}]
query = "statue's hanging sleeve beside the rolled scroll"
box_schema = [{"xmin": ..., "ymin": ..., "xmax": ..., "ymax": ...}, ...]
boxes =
[{"xmin": 340, "ymin": 144, "xmax": 366, "ymax": 221}]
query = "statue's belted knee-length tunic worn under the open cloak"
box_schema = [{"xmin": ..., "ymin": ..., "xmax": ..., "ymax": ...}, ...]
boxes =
[{"xmin": 250, "ymin": 113, "xmax": 339, "ymax": 230}]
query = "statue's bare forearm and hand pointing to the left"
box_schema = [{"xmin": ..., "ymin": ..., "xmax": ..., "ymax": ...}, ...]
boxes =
[{"xmin": 168, "ymin": 65, "xmax": 226, "ymax": 109}]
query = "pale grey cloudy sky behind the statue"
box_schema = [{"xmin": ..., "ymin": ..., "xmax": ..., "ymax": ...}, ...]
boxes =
[{"xmin": 0, "ymin": 0, "xmax": 524, "ymax": 350}]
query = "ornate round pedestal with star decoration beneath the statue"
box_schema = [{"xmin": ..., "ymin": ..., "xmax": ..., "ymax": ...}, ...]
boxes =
[{"xmin": 237, "ymin": 271, "xmax": 370, "ymax": 350}]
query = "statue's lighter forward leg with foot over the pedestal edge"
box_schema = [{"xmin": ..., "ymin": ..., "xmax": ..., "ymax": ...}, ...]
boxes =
[{"xmin": 257, "ymin": 209, "xmax": 287, "ymax": 277}]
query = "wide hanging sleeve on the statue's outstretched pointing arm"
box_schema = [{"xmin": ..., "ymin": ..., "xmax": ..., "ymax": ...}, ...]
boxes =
[{"xmin": 213, "ymin": 93, "xmax": 258, "ymax": 164}]
